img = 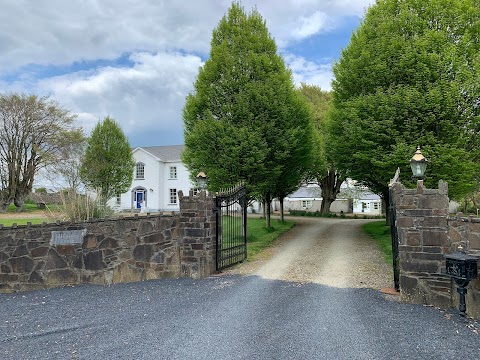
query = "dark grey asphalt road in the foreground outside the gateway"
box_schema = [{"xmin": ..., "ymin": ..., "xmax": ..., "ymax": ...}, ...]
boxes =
[{"xmin": 0, "ymin": 218, "xmax": 480, "ymax": 359}]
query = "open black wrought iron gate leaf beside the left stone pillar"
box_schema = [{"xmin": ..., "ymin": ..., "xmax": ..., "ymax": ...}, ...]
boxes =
[{"xmin": 215, "ymin": 185, "xmax": 247, "ymax": 271}]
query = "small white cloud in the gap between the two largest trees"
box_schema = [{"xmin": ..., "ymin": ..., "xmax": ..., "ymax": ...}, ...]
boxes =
[{"xmin": 284, "ymin": 54, "xmax": 333, "ymax": 90}]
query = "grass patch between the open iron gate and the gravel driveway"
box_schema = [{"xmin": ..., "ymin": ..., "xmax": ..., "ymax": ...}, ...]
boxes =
[{"xmin": 247, "ymin": 218, "xmax": 295, "ymax": 259}]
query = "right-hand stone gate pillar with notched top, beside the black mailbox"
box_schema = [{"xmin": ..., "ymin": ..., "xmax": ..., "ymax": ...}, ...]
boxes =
[{"xmin": 394, "ymin": 181, "xmax": 451, "ymax": 307}]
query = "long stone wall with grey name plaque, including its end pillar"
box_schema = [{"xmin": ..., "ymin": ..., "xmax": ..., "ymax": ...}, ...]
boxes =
[{"xmin": 0, "ymin": 193, "xmax": 215, "ymax": 292}]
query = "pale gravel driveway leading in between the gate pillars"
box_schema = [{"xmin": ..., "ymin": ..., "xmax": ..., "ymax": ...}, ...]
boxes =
[{"xmin": 226, "ymin": 217, "xmax": 393, "ymax": 289}]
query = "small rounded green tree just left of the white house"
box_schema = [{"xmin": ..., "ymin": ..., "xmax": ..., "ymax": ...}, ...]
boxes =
[{"xmin": 80, "ymin": 116, "xmax": 135, "ymax": 200}]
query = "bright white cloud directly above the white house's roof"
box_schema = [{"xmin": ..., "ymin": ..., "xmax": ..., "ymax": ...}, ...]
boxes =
[{"xmin": 38, "ymin": 52, "xmax": 202, "ymax": 143}]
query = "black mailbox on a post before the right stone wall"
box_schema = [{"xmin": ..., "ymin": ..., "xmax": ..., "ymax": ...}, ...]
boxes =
[{"xmin": 445, "ymin": 247, "xmax": 478, "ymax": 316}]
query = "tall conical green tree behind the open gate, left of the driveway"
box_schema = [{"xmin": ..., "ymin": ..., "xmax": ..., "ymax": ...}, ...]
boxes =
[{"xmin": 182, "ymin": 3, "xmax": 312, "ymax": 227}]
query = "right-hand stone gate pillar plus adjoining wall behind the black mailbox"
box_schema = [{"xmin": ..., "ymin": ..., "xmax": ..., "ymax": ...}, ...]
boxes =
[{"xmin": 393, "ymin": 181, "xmax": 480, "ymax": 318}]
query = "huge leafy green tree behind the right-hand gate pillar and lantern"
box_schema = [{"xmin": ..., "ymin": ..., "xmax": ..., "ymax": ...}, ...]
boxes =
[{"xmin": 329, "ymin": 0, "xmax": 480, "ymax": 218}]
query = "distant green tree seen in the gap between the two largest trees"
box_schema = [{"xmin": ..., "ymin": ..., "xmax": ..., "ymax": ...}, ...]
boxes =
[{"xmin": 299, "ymin": 84, "xmax": 346, "ymax": 214}]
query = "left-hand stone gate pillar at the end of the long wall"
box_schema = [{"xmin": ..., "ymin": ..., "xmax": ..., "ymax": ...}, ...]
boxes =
[{"xmin": 178, "ymin": 191, "xmax": 216, "ymax": 278}]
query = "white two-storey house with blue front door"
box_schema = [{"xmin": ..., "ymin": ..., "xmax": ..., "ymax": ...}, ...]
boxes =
[{"xmin": 115, "ymin": 145, "xmax": 194, "ymax": 212}]
